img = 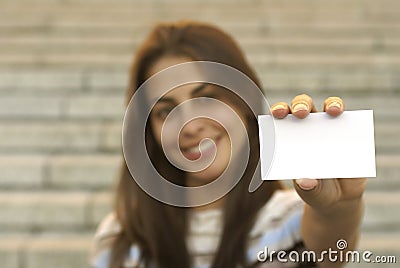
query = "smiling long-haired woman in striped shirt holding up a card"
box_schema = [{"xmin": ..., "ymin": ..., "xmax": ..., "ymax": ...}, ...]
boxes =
[{"xmin": 92, "ymin": 22, "xmax": 365, "ymax": 268}]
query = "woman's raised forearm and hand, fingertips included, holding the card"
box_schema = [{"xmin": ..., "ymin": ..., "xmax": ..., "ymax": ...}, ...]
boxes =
[{"xmin": 271, "ymin": 94, "xmax": 366, "ymax": 267}]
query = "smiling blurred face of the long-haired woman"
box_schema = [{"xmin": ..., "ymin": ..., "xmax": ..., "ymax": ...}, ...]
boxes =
[{"xmin": 147, "ymin": 56, "xmax": 245, "ymax": 186}]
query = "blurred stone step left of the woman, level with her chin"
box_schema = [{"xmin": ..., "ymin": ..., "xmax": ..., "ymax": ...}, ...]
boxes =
[{"xmin": 0, "ymin": 152, "xmax": 119, "ymax": 191}]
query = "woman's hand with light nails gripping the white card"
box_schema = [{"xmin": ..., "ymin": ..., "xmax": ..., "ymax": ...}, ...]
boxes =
[{"xmin": 271, "ymin": 94, "xmax": 366, "ymax": 212}]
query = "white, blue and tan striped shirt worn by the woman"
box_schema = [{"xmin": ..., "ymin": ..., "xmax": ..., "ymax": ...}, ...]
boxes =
[{"xmin": 91, "ymin": 190, "xmax": 314, "ymax": 268}]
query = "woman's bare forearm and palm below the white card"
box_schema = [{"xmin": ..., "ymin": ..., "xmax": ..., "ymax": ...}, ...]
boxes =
[{"xmin": 295, "ymin": 179, "xmax": 365, "ymax": 267}]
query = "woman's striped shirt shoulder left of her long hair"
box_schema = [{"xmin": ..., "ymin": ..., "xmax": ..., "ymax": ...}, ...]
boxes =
[{"xmin": 90, "ymin": 213, "xmax": 121, "ymax": 267}]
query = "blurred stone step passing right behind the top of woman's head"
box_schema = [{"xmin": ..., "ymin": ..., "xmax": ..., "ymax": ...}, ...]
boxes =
[{"xmin": 0, "ymin": 24, "xmax": 400, "ymax": 42}]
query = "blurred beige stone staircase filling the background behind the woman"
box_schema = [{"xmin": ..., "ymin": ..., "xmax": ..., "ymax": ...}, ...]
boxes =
[{"xmin": 0, "ymin": 0, "xmax": 400, "ymax": 268}]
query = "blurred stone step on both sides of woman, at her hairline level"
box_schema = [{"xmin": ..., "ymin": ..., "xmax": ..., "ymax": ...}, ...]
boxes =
[{"xmin": 0, "ymin": 51, "xmax": 400, "ymax": 67}]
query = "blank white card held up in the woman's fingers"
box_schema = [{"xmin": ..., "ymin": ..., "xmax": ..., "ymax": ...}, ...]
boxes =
[{"xmin": 258, "ymin": 110, "xmax": 376, "ymax": 180}]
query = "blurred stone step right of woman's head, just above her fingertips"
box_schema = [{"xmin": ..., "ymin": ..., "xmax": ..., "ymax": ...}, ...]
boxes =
[{"xmin": 255, "ymin": 70, "xmax": 398, "ymax": 93}]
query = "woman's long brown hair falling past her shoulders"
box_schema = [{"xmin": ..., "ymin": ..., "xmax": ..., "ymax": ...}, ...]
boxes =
[{"xmin": 110, "ymin": 21, "xmax": 281, "ymax": 268}]
